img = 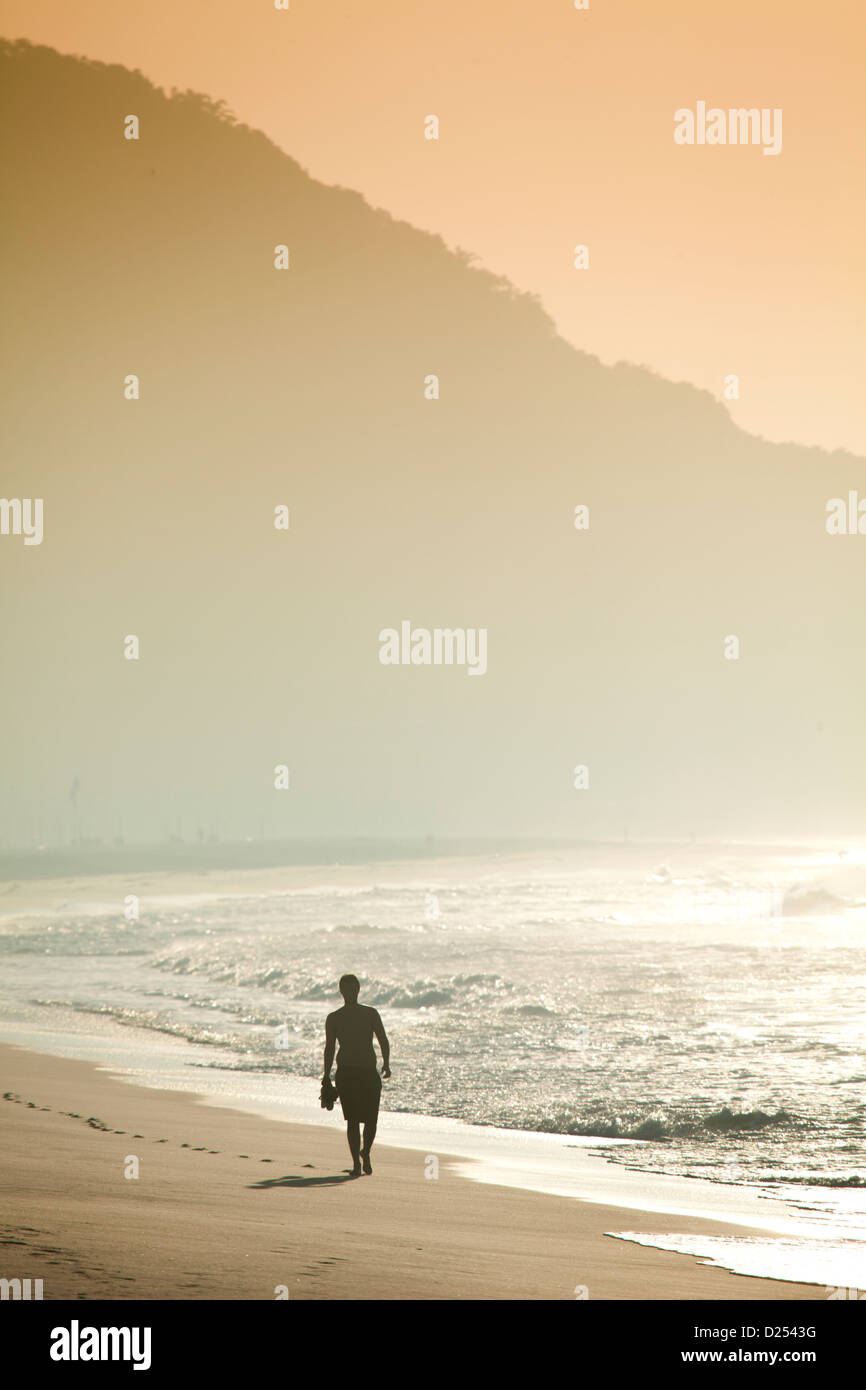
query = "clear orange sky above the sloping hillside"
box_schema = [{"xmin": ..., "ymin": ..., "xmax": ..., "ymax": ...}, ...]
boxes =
[{"xmin": 0, "ymin": 0, "xmax": 866, "ymax": 456}]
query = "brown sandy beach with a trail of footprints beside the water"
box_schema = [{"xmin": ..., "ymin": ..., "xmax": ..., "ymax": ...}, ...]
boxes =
[{"xmin": 0, "ymin": 1045, "xmax": 826, "ymax": 1300}]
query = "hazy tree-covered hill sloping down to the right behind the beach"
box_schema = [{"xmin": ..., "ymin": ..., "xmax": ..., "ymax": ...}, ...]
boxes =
[{"xmin": 0, "ymin": 42, "xmax": 866, "ymax": 844}]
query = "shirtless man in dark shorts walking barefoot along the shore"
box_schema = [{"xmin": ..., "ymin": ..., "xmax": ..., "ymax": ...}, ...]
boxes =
[{"xmin": 325, "ymin": 974, "xmax": 391, "ymax": 1177}]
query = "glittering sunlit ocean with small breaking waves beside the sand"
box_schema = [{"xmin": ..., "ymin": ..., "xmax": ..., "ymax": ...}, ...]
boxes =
[{"xmin": 0, "ymin": 845, "xmax": 866, "ymax": 1278}]
